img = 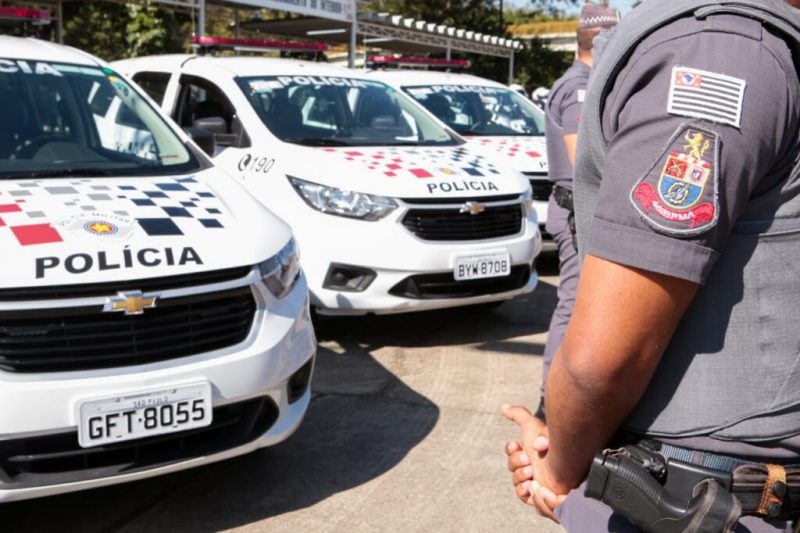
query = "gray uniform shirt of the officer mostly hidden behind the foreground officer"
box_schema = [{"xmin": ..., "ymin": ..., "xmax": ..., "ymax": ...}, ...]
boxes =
[{"xmin": 546, "ymin": 60, "xmax": 590, "ymax": 190}]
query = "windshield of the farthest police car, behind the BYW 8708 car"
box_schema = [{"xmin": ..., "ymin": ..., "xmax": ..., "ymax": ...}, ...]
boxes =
[{"xmin": 403, "ymin": 85, "xmax": 545, "ymax": 136}]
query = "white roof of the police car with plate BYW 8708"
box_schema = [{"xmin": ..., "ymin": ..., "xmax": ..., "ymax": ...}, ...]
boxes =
[{"xmin": 114, "ymin": 54, "xmax": 384, "ymax": 79}]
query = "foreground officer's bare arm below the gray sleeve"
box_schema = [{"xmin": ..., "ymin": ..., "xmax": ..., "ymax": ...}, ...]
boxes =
[{"xmin": 545, "ymin": 256, "xmax": 697, "ymax": 490}]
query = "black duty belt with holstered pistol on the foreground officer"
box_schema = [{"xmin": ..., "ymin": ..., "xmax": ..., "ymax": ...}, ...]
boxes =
[{"xmin": 586, "ymin": 438, "xmax": 800, "ymax": 533}]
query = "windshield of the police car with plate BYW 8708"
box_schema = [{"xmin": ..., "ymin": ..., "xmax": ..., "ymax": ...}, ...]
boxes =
[{"xmin": 238, "ymin": 76, "xmax": 461, "ymax": 146}]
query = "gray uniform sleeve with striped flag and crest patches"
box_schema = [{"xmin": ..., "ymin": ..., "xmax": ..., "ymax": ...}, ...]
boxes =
[{"xmin": 587, "ymin": 23, "xmax": 798, "ymax": 284}]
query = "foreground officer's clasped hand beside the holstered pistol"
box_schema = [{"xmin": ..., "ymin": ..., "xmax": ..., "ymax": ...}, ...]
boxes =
[{"xmin": 502, "ymin": 405, "xmax": 567, "ymax": 522}]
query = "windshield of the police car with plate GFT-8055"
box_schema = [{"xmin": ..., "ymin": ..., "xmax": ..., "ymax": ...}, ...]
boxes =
[{"xmin": 0, "ymin": 58, "xmax": 199, "ymax": 179}]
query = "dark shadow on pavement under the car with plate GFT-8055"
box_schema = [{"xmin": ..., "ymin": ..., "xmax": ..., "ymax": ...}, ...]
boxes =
[{"xmin": 0, "ymin": 340, "xmax": 439, "ymax": 533}]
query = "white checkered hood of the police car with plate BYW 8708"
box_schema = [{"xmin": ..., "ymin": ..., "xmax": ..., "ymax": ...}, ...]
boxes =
[{"xmin": 286, "ymin": 145, "xmax": 528, "ymax": 198}]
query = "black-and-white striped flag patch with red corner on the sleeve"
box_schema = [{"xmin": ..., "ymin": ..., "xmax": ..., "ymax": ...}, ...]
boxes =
[{"xmin": 667, "ymin": 67, "xmax": 747, "ymax": 128}]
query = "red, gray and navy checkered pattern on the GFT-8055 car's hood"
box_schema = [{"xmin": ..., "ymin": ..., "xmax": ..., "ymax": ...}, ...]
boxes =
[{"xmin": 0, "ymin": 177, "xmax": 226, "ymax": 246}]
